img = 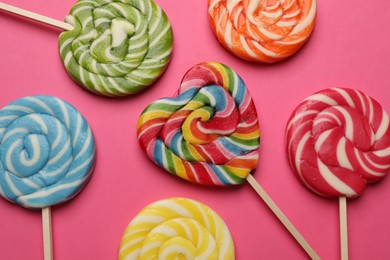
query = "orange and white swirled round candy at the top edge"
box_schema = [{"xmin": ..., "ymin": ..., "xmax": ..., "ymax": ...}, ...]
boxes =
[{"xmin": 208, "ymin": 0, "xmax": 317, "ymax": 63}]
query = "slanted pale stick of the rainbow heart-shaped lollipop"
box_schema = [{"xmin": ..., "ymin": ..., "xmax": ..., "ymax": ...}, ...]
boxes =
[{"xmin": 246, "ymin": 174, "xmax": 321, "ymax": 259}]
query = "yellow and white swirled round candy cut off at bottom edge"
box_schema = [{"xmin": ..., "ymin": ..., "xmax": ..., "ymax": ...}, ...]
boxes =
[{"xmin": 119, "ymin": 198, "xmax": 234, "ymax": 260}]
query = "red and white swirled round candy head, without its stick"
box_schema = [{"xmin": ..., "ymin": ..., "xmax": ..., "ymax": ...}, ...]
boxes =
[{"xmin": 286, "ymin": 88, "xmax": 390, "ymax": 198}]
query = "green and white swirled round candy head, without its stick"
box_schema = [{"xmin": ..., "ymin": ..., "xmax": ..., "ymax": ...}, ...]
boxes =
[{"xmin": 59, "ymin": 0, "xmax": 173, "ymax": 96}]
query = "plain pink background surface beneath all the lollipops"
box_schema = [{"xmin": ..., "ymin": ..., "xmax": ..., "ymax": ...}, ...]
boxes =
[{"xmin": 0, "ymin": 0, "xmax": 390, "ymax": 260}]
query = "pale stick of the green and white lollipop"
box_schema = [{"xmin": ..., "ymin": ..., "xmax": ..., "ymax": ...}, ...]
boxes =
[{"xmin": 0, "ymin": 3, "xmax": 74, "ymax": 31}]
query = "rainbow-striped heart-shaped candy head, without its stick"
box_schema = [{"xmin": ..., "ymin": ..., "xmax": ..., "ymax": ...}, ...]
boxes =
[{"xmin": 137, "ymin": 62, "xmax": 260, "ymax": 185}]
